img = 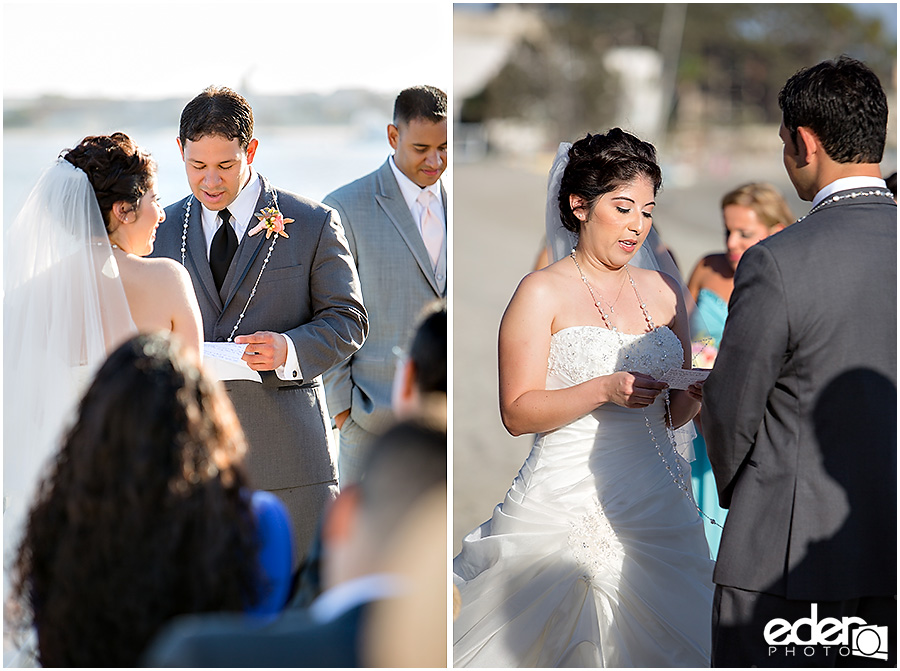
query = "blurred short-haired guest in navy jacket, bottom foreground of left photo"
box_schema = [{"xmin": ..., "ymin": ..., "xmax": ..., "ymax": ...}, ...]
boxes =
[{"xmin": 144, "ymin": 422, "xmax": 449, "ymax": 667}]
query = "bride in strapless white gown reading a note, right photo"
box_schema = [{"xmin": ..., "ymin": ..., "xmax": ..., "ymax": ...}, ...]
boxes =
[{"xmin": 453, "ymin": 128, "xmax": 713, "ymax": 667}]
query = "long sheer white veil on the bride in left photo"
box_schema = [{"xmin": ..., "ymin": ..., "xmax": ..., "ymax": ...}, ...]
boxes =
[{"xmin": 3, "ymin": 159, "xmax": 136, "ymax": 576}]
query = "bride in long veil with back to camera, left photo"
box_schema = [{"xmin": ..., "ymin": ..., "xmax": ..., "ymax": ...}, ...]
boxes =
[{"xmin": 3, "ymin": 133, "xmax": 202, "ymax": 608}]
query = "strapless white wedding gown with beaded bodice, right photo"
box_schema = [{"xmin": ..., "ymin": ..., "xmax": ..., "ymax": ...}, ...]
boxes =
[{"xmin": 453, "ymin": 326, "xmax": 713, "ymax": 667}]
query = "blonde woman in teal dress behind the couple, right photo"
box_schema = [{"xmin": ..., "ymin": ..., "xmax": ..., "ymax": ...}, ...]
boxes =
[{"xmin": 688, "ymin": 182, "xmax": 794, "ymax": 559}]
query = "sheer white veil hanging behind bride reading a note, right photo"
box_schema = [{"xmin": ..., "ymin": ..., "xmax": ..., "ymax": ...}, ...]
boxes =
[{"xmin": 545, "ymin": 142, "xmax": 703, "ymax": 461}]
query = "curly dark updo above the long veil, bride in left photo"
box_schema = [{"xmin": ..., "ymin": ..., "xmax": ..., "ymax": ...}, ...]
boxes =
[{"xmin": 60, "ymin": 133, "xmax": 156, "ymax": 233}]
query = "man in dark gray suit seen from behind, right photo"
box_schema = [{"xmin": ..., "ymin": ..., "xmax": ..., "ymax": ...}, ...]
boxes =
[{"xmin": 703, "ymin": 57, "xmax": 897, "ymax": 666}]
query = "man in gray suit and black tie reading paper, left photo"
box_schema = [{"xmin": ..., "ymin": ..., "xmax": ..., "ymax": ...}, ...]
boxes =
[{"xmin": 154, "ymin": 87, "xmax": 368, "ymax": 566}]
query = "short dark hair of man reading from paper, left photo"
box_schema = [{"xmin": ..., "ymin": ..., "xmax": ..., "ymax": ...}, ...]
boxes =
[{"xmin": 178, "ymin": 86, "xmax": 253, "ymax": 151}]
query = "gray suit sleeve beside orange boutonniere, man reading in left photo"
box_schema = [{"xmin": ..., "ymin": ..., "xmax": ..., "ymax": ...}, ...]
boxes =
[{"xmin": 287, "ymin": 205, "xmax": 369, "ymax": 380}]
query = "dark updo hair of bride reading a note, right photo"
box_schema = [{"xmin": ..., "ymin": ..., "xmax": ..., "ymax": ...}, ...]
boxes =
[{"xmin": 559, "ymin": 128, "xmax": 662, "ymax": 234}]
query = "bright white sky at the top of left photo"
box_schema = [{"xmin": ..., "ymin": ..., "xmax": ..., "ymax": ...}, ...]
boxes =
[{"xmin": 2, "ymin": 0, "xmax": 452, "ymax": 100}]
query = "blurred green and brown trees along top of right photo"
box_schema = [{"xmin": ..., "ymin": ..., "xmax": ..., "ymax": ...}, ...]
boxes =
[{"xmin": 460, "ymin": 3, "xmax": 897, "ymax": 141}]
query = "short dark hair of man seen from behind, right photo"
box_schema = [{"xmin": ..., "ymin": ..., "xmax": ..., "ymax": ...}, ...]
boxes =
[{"xmin": 778, "ymin": 56, "xmax": 888, "ymax": 163}]
